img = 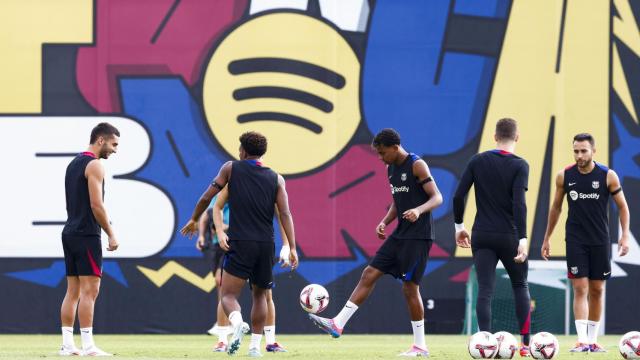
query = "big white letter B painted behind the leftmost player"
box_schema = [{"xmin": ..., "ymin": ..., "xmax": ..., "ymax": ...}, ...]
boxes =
[{"xmin": 0, "ymin": 116, "xmax": 175, "ymax": 258}]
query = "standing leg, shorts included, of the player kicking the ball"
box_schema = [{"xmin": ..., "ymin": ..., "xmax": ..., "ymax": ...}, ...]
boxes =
[{"xmin": 397, "ymin": 240, "xmax": 433, "ymax": 356}]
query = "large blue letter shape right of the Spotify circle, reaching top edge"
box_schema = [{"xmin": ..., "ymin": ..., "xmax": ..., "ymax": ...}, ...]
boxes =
[{"xmin": 362, "ymin": 0, "xmax": 496, "ymax": 155}]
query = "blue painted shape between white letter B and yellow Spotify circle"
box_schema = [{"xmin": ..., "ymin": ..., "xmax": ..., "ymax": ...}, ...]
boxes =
[{"xmin": 120, "ymin": 78, "xmax": 228, "ymax": 257}]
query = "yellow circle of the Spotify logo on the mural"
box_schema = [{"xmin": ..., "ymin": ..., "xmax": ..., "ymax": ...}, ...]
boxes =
[{"xmin": 203, "ymin": 13, "xmax": 361, "ymax": 174}]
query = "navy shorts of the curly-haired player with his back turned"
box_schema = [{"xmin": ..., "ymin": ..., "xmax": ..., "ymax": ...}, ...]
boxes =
[{"xmin": 222, "ymin": 240, "xmax": 275, "ymax": 289}]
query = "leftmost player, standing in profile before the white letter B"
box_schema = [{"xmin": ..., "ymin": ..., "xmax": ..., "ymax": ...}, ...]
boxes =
[{"xmin": 59, "ymin": 123, "xmax": 120, "ymax": 356}]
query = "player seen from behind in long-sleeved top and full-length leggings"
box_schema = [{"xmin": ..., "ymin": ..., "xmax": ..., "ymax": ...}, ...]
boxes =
[{"xmin": 453, "ymin": 118, "xmax": 531, "ymax": 356}]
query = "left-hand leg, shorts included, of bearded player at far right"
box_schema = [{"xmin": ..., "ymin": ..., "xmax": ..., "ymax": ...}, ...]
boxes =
[{"xmin": 566, "ymin": 242, "xmax": 589, "ymax": 352}]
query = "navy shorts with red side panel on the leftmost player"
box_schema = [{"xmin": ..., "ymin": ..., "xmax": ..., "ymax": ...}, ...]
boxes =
[{"xmin": 62, "ymin": 234, "xmax": 102, "ymax": 277}]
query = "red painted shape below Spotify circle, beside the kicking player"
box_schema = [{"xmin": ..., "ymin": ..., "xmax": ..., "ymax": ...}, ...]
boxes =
[{"xmin": 287, "ymin": 145, "xmax": 395, "ymax": 258}]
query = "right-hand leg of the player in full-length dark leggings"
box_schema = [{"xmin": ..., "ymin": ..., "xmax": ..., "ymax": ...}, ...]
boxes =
[{"xmin": 498, "ymin": 236, "xmax": 531, "ymax": 356}]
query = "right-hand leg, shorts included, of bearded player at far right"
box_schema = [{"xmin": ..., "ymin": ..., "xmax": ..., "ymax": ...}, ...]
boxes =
[{"xmin": 587, "ymin": 245, "xmax": 611, "ymax": 352}]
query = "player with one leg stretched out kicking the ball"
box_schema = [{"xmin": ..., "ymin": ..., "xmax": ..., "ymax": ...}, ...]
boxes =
[{"xmin": 309, "ymin": 129, "xmax": 442, "ymax": 356}]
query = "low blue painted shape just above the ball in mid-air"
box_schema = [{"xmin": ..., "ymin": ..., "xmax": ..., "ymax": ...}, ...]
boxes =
[{"xmin": 273, "ymin": 243, "xmax": 367, "ymax": 285}]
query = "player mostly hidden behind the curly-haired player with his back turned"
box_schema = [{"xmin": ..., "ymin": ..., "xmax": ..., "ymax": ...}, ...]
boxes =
[{"xmin": 205, "ymin": 187, "xmax": 290, "ymax": 352}]
